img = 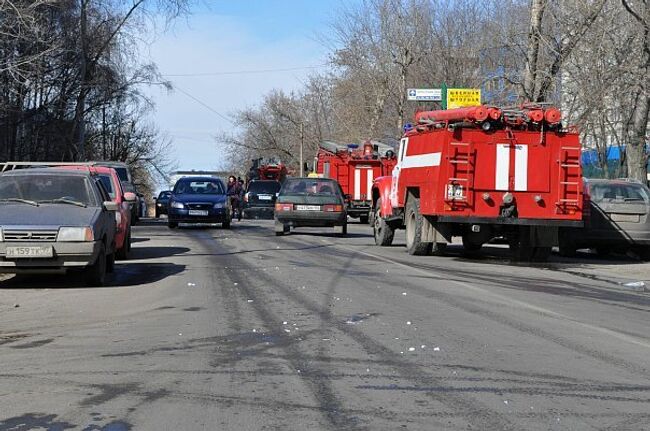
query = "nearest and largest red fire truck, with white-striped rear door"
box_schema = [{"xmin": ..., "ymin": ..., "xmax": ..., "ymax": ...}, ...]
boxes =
[{"xmin": 372, "ymin": 104, "xmax": 583, "ymax": 261}]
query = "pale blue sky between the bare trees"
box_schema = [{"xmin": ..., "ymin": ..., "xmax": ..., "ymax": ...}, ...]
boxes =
[{"xmin": 144, "ymin": 0, "xmax": 356, "ymax": 174}]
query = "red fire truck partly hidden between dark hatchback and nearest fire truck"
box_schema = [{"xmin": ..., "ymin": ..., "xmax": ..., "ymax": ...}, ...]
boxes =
[{"xmin": 316, "ymin": 141, "xmax": 397, "ymax": 223}]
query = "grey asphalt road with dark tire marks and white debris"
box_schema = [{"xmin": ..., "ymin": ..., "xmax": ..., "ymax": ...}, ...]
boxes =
[{"xmin": 0, "ymin": 221, "xmax": 650, "ymax": 431}]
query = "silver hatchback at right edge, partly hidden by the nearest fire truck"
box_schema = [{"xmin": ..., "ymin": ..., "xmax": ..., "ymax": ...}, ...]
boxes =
[{"xmin": 559, "ymin": 179, "xmax": 650, "ymax": 260}]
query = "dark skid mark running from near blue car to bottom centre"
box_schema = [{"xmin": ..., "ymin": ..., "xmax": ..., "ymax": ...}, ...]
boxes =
[{"xmin": 187, "ymin": 231, "xmax": 366, "ymax": 430}]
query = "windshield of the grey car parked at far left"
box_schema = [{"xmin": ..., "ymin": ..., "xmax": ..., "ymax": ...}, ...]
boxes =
[{"xmin": 0, "ymin": 174, "xmax": 95, "ymax": 205}]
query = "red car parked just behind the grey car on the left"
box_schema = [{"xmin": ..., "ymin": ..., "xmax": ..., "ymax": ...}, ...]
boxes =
[{"xmin": 58, "ymin": 165, "xmax": 137, "ymax": 260}]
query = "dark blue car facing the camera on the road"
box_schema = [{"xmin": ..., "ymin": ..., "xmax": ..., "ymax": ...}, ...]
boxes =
[{"xmin": 167, "ymin": 177, "xmax": 231, "ymax": 229}]
